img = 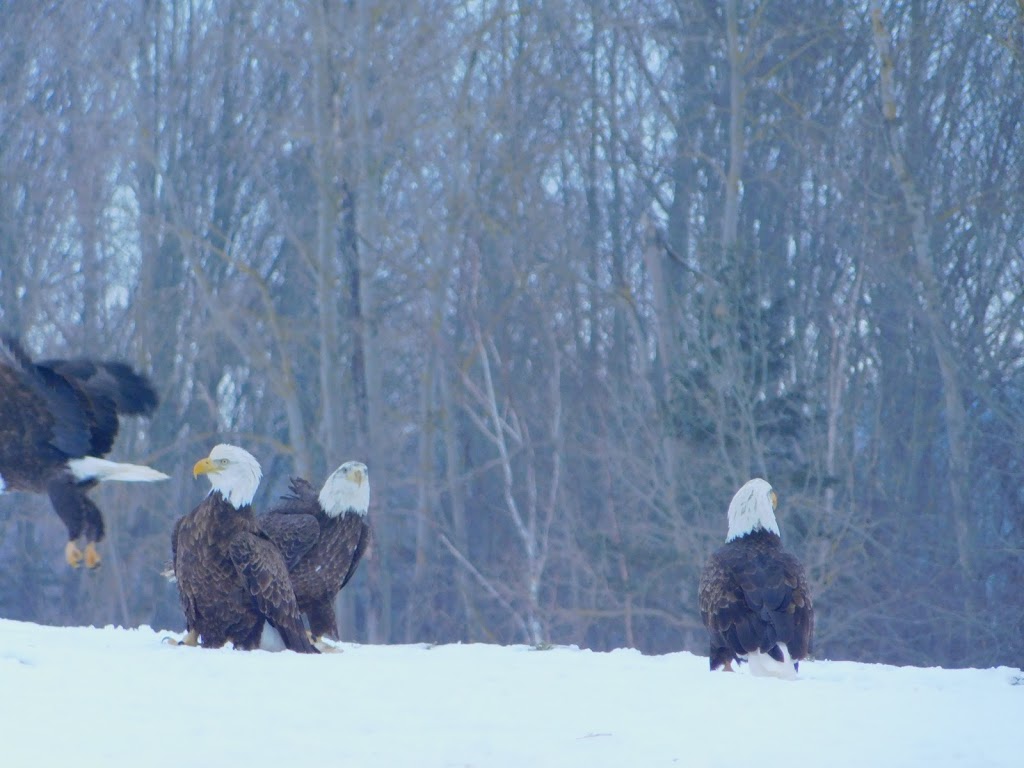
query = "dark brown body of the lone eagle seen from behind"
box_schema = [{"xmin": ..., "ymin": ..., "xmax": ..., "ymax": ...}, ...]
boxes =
[{"xmin": 698, "ymin": 529, "xmax": 814, "ymax": 670}]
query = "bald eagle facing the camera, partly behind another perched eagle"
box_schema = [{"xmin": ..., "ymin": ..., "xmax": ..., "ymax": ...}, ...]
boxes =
[{"xmin": 258, "ymin": 462, "xmax": 370, "ymax": 640}]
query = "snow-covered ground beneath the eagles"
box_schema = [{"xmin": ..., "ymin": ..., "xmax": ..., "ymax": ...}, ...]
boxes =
[{"xmin": 0, "ymin": 621, "xmax": 1024, "ymax": 768}]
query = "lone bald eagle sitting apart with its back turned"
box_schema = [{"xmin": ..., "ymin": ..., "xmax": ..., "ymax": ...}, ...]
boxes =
[{"xmin": 698, "ymin": 478, "xmax": 814, "ymax": 677}]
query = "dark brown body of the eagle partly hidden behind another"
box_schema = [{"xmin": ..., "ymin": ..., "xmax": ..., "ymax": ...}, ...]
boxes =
[{"xmin": 259, "ymin": 478, "xmax": 370, "ymax": 640}]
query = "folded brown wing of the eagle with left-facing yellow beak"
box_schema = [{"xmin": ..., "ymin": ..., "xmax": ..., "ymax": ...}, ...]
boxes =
[{"xmin": 228, "ymin": 531, "xmax": 319, "ymax": 653}]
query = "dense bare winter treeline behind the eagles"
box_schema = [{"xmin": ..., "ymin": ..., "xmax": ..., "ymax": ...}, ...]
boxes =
[{"xmin": 0, "ymin": 0, "xmax": 1024, "ymax": 665}]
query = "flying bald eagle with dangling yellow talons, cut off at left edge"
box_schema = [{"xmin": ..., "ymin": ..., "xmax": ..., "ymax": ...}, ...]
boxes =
[{"xmin": 0, "ymin": 337, "xmax": 167, "ymax": 568}]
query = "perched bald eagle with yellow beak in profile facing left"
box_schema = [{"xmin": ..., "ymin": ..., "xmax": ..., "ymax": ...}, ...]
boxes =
[{"xmin": 171, "ymin": 443, "xmax": 317, "ymax": 653}]
